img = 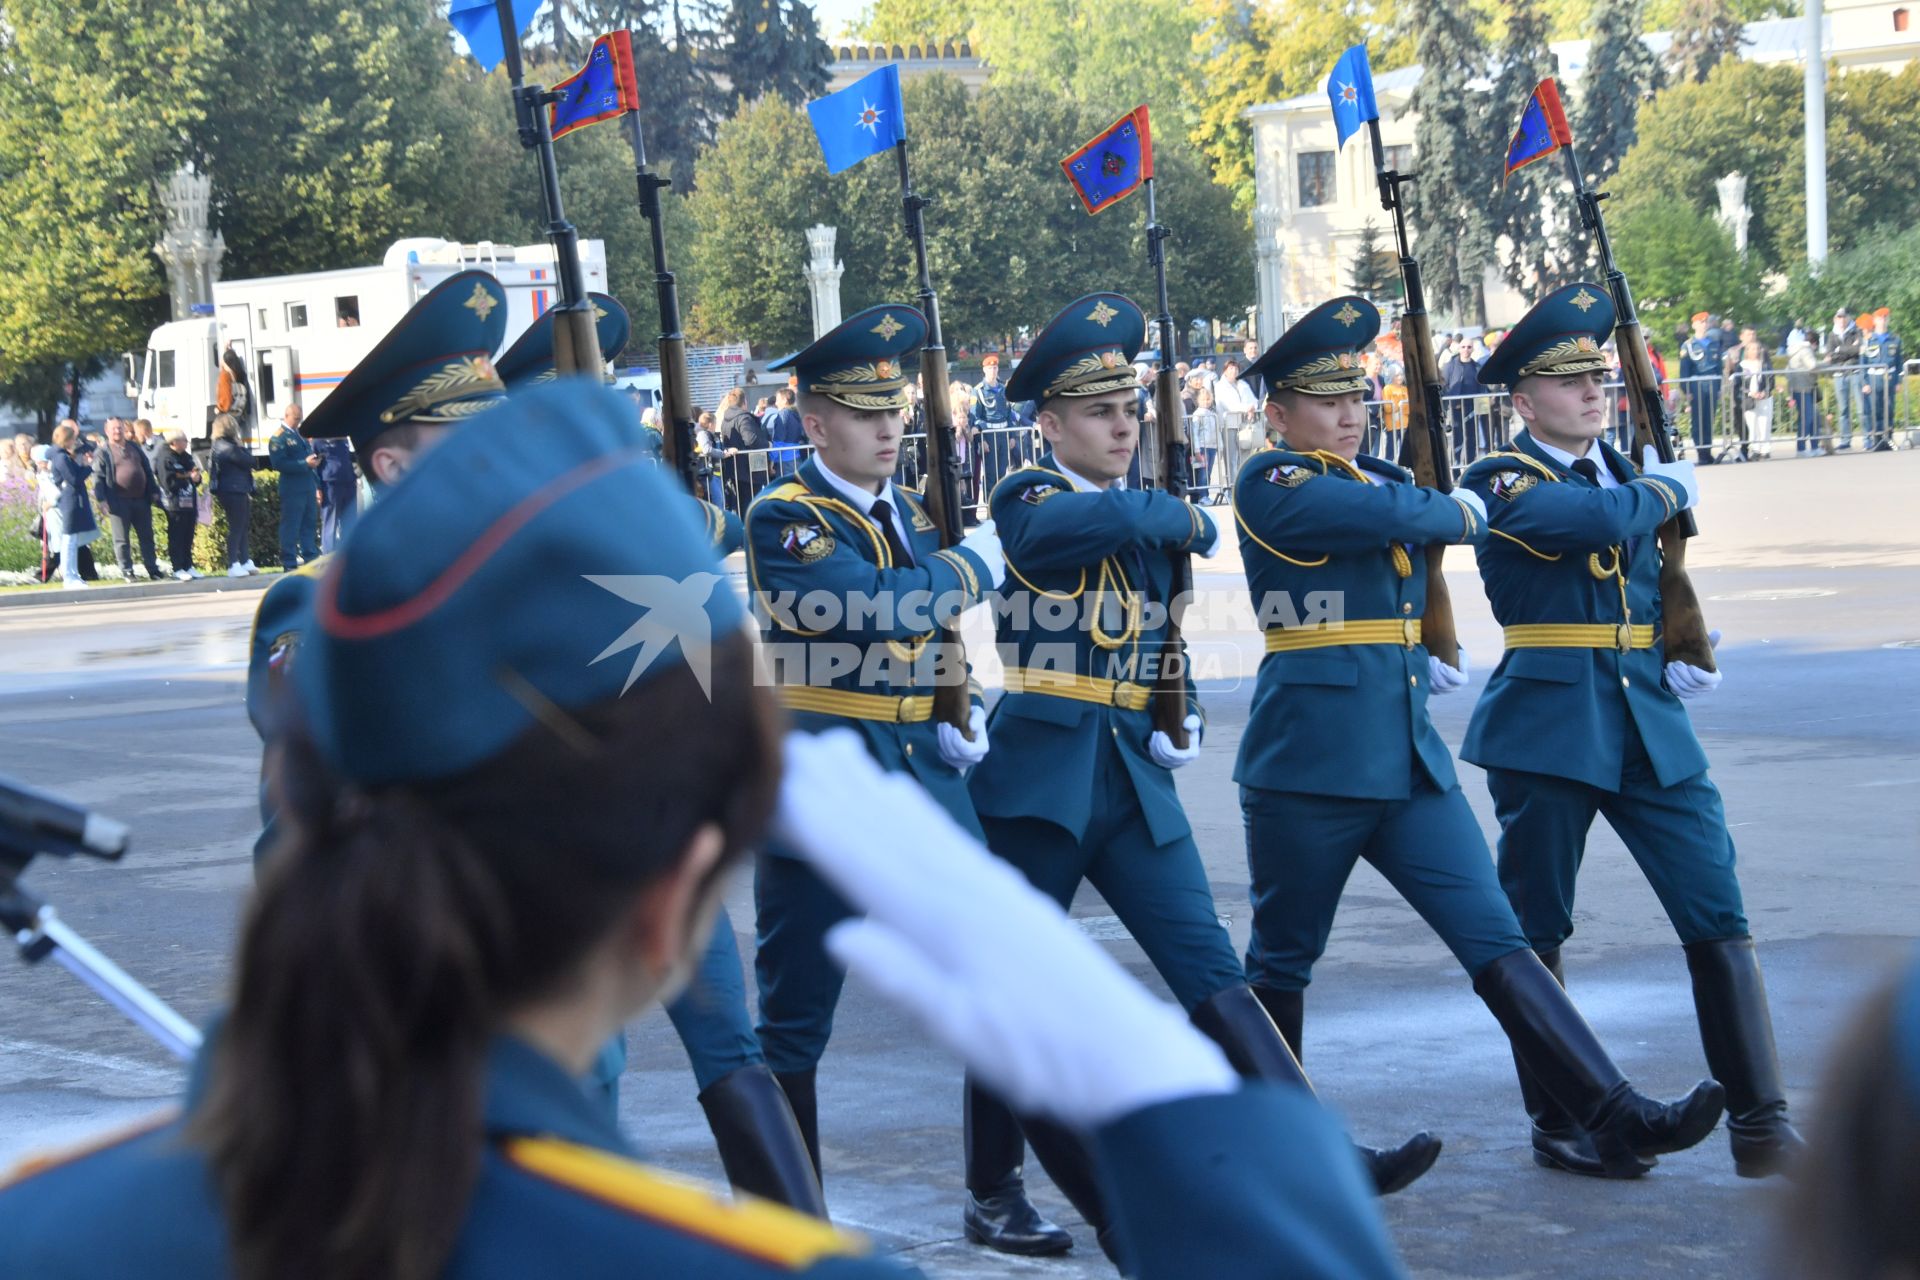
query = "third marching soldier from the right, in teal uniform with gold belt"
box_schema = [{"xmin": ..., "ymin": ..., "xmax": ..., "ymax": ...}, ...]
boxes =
[{"xmin": 970, "ymin": 294, "xmax": 1438, "ymax": 1244}]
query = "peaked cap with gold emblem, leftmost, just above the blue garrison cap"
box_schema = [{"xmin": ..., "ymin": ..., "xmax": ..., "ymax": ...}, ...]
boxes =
[{"xmin": 300, "ymin": 271, "xmax": 507, "ymax": 455}]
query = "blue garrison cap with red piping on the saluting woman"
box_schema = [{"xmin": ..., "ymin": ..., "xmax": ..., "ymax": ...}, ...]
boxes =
[{"xmin": 292, "ymin": 380, "xmax": 745, "ymax": 785}]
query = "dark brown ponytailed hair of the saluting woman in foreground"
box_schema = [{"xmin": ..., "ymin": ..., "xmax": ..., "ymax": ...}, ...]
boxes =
[{"xmin": 192, "ymin": 633, "xmax": 780, "ymax": 1280}]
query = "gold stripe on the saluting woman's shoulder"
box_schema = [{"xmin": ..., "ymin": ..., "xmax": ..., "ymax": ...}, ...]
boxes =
[{"xmin": 505, "ymin": 1138, "xmax": 870, "ymax": 1270}]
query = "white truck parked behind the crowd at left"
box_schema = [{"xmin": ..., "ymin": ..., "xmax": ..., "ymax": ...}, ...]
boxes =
[{"xmin": 125, "ymin": 238, "xmax": 607, "ymax": 451}]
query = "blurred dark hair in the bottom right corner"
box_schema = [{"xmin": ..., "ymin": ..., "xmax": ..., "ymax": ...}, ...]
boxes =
[{"xmin": 1774, "ymin": 973, "xmax": 1920, "ymax": 1280}]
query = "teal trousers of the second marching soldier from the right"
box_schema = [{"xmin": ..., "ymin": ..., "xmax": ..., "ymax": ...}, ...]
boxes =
[{"xmin": 1240, "ymin": 777, "xmax": 1526, "ymax": 990}]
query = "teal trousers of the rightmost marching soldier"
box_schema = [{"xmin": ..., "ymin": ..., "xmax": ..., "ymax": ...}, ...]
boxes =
[{"xmin": 1486, "ymin": 733, "xmax": 1747, "ymax": 952}]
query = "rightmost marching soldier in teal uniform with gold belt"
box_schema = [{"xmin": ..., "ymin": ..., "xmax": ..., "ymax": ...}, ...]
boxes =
[{"xmin": 1461, "ymin": 284, "xmax": 1803, "ymax": 1176}]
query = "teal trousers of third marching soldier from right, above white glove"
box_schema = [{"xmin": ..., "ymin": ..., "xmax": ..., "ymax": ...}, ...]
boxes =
[{"xmin": 981, "ymin": 733, "xmax": 1246, "ymax": 1011}]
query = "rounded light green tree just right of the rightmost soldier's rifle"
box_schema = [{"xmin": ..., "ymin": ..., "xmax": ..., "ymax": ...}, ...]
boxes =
[{"xmin": 1607, "ymin": 200, "xmax": 1763, "ymax": 334}]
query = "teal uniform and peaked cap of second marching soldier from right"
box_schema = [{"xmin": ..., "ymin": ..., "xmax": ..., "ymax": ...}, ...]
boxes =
[{"xmin": 1233, "ymin": 297, "xmax": 1526, "ymax": 997}]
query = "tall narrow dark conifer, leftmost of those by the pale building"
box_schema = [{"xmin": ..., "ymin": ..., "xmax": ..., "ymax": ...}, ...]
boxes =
[{"xmin": 1402, "ymin": 0, "xmax": 1494, "ymax": 322}]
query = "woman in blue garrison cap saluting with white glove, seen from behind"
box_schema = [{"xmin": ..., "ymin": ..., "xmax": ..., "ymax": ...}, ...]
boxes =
[{"xmin": 0, "ymin": 382, "xmax": 1402, "ymax": 1280}]
